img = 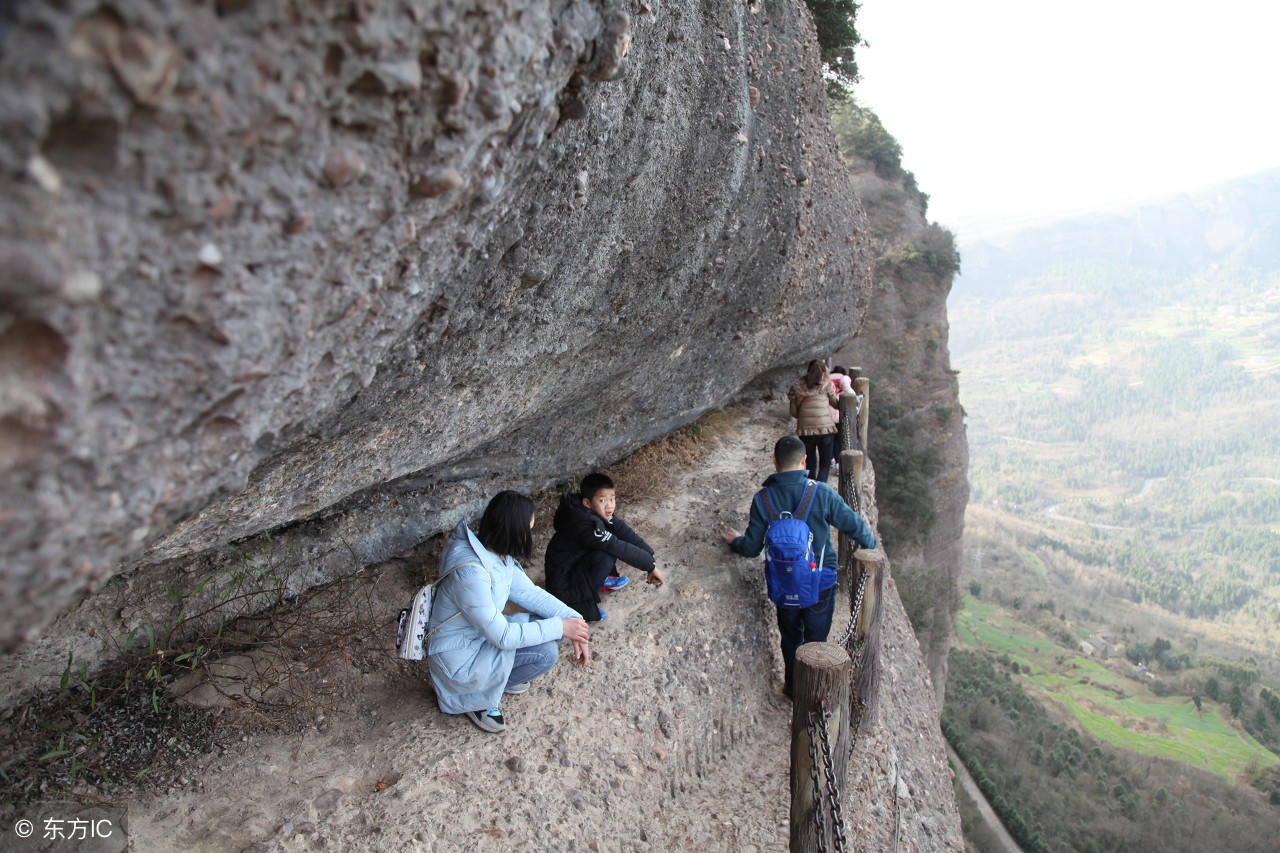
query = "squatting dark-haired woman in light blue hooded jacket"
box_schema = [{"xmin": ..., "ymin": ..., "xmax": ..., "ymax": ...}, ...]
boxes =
[{"xmin": 426, "ymin": 491, "xmax": 589, "ymax": 731}]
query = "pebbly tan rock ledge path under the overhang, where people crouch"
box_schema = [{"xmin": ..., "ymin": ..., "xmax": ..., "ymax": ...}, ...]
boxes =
[{"xmin": 5, "ymin": 400, "xmax": 963, "ymax": 853}]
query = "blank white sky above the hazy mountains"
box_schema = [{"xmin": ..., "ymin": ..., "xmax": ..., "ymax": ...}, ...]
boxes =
[{"xmin": 856, "ymin": 0, "xmax": 1280, "ymax": 230}]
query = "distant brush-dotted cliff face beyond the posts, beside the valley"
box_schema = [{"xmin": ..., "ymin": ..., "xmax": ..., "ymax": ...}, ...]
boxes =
[{"xmin": 835, "ymin": 139, "xmax": 969, "ymax": 708}]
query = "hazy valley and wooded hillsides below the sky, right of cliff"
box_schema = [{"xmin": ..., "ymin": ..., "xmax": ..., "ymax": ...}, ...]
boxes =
[{"xmin": 947, "ymin": 172, "xmax": 1280, "ymax": 850}]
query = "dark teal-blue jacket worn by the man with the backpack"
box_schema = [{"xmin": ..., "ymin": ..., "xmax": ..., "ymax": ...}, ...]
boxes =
[{"xmin": 730, "ymin": 469, "xmax": 876, "ymax": 589}]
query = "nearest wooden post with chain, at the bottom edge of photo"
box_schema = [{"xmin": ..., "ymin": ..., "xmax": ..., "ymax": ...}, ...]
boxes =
[{"xmin": 791, "ymin": 643, "xmax": 852, "ymax": 853}]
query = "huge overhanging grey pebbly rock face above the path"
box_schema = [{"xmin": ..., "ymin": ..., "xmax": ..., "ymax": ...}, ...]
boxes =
[{"xmin": 0, "ymin": 0, "xmax": 870, "ymax": 675}]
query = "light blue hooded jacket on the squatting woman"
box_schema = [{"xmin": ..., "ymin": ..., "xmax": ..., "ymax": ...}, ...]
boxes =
[{"xmin": 426, "ymin": 521, "xmax": 581, "ymax": 713}]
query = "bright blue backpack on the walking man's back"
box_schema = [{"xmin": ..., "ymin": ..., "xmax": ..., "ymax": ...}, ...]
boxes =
[{"xmin": 755, "ymin": 480, "xmax": 826, "ymax": 610}]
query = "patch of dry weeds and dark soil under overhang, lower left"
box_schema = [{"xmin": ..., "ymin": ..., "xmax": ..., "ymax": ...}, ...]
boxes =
[{"xmin": 0, "ymin": 569, "xmax": 394, "ymax": 804}]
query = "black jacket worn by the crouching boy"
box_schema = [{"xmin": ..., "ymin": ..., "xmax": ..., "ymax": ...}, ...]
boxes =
[{"xmin": 544, "ymin": 492, "xmax": 654, "ymax": 615}]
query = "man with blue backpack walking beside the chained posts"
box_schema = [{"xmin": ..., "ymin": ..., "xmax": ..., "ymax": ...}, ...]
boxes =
[{"xmin": 722, "ymin": 435, "xmax": 876, "ymax": 697}]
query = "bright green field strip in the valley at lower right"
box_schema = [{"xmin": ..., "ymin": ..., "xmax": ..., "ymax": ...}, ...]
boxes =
[{"xmin": 956, "ymin": 596, "xmax": 1280, "ymax": 780}]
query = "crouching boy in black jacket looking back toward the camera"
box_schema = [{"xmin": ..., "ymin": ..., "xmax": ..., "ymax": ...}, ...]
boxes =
[{"xmin": 545, "ymin": 473, "xmax": 664, "ymax": 622}]
